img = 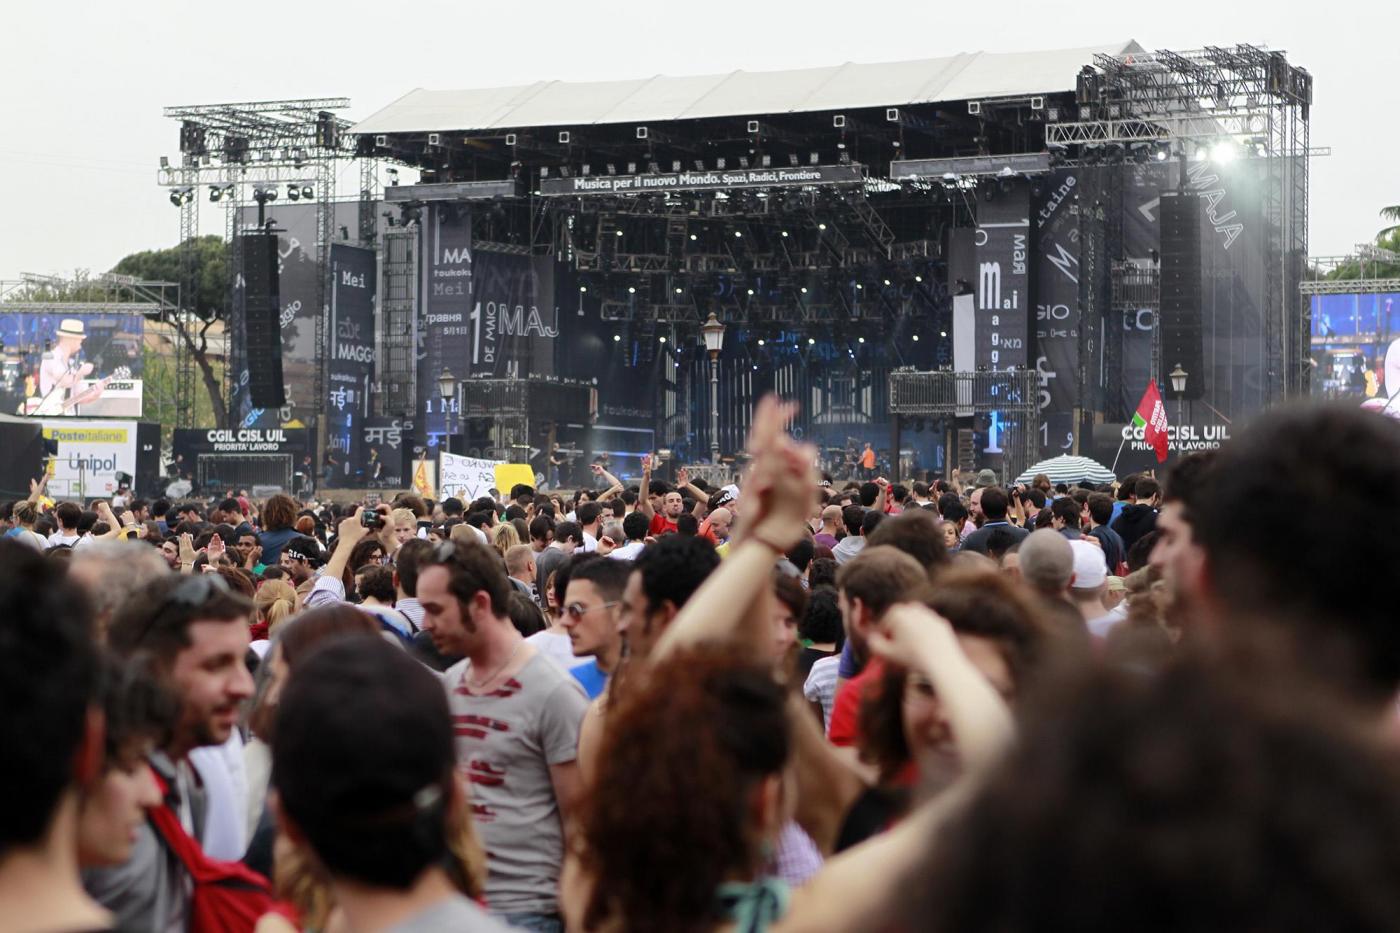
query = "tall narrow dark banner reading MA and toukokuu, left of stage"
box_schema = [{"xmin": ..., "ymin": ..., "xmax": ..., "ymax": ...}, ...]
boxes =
[{"xmin": 419, "ymin": 203, "xmax": 473, "ymax": 434}]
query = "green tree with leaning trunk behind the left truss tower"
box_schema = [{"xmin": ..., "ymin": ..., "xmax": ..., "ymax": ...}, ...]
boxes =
[{"xmin": 112, "ymin": 235, "xmax": 228, "ymax": 427}]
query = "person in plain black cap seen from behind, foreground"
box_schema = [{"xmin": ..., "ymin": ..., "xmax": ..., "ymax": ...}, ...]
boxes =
[{"xmin": 272, "ymin": 639, "xmax": 507, "ymax": 933}]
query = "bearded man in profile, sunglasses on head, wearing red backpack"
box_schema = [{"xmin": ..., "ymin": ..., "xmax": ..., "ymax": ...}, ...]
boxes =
[{"xmin": 84, "ymin": 573, "xmax": 253, "ymax": 930}]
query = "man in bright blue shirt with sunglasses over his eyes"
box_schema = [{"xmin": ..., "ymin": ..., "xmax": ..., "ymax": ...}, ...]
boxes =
[{"xmin": 563, "ymin": 555, "xmax": 631, "ymax": 699}]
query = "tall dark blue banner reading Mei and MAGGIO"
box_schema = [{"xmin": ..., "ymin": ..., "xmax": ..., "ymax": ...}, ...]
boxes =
[{"xmin": 323, "ymin": 242, "xmax": 375, "ymax": 486}]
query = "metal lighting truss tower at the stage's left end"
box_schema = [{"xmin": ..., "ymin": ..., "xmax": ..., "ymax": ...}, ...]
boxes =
[{"xmin": 158, "ymin": 97, "xmax": 355, "ymax": 426}]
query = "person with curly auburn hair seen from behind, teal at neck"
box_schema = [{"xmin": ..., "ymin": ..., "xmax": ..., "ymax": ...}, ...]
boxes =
[{"xmin": 564, "ymin": 649, "xmax": 791, "ymax": 933}]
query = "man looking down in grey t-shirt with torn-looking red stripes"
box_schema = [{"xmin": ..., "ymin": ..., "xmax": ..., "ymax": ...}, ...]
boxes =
[{"xmin": 417, "ymin": 541, "xmax": 588, "ymax": 932}]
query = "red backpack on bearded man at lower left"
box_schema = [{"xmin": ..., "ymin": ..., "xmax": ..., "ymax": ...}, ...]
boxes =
[{"xmin": 150, "ymin": 769, "xmax": 281, "ymax": 933}]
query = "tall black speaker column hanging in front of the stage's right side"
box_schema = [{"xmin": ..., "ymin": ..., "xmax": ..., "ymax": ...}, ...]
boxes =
[{"xmin": 1158, "ymin": 192, "xmax": 1208, "ymax": 399}]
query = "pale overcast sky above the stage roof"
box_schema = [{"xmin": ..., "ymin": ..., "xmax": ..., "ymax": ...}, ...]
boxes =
[{"xmin": 0, "ymin": 0, "xmax": 1400, "ymax": 279}]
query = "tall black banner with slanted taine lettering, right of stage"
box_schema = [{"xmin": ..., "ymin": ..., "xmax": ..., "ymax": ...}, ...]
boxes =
[{"xmin": 1032, "ymin": 168, "xmax": 1079, "ymax": 457}]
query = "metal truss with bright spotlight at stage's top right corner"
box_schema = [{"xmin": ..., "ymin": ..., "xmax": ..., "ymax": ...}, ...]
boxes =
[{"xmin": 1046, "ymin": 45, "xmax": 1313, "ymax": 402}]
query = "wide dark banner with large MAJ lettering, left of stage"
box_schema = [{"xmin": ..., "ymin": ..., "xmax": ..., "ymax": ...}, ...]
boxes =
[{"xmin": 469, "ymin": 249, "xmax": 559, "ymax": 378}]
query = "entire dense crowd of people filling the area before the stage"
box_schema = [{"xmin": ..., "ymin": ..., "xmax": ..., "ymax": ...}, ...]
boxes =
[{"xmin": 0, "ymin": 398, "xmax": 1400, "ymax": 933}]
